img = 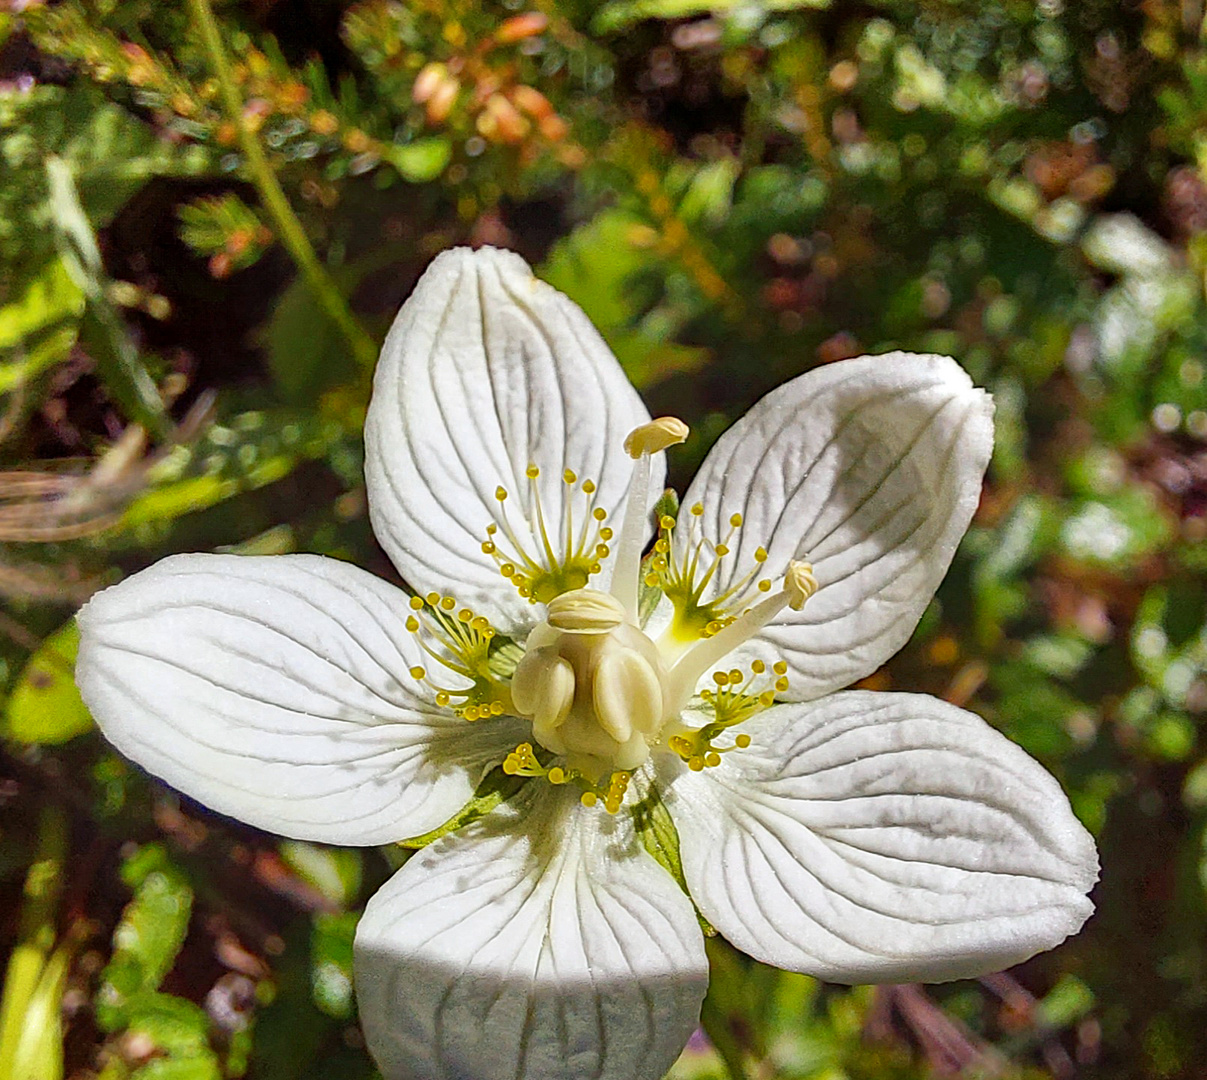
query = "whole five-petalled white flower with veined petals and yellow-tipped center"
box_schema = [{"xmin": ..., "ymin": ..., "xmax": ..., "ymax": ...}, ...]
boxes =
[{"xmin": 78, "ymin": 250, "xmax": 1097, "ymax": 1080}]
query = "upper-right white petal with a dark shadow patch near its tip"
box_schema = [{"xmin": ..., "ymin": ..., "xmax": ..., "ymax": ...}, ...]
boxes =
[{"xmin": 677, "ymin": 352, "xmax": 993, "ymax": 701}]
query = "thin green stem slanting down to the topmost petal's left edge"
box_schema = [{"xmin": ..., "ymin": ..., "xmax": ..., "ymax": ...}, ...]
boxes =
[{"xmin": 189, "ymin": 0, "xmax": 378, "ymax": 370}]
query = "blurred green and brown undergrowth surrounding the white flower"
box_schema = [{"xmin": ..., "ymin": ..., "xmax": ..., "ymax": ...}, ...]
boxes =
[{"xmin": 0, "ymin": 0, "xmax": 1207, "ymax": 1080}]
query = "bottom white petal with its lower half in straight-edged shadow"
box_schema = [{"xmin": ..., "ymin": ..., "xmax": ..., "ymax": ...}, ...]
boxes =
[{"xmin": 356, "ymin": 787, "xmax": 707, "ymax": 1080}]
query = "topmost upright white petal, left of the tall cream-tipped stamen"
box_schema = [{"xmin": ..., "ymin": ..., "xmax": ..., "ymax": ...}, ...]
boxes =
[{"xmin": 365, "ymin": 247, "xmax": 665, "ymax": 631}]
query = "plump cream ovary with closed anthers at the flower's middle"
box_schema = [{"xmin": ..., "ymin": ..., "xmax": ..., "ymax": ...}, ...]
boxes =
[{"xmin": 511, "ymin": 589, "xmax": 666, "ymax": 783}]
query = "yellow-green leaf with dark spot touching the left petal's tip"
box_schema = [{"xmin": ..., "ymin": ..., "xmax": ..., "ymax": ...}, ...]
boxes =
[{"xmin": 4, "ymin": 619, "xmax": 93, "ymax": 746}]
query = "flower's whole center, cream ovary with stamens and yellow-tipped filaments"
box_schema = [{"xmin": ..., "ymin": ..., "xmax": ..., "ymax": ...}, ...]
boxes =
[{"xmin": 407, "ymin": 416, "xmax": 817, "ymax": 813}]
